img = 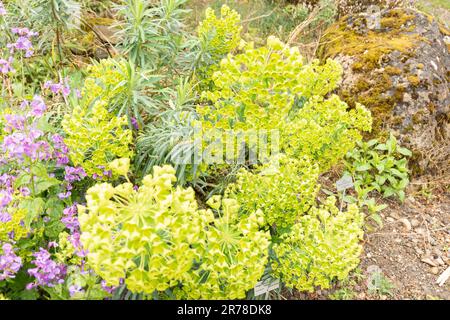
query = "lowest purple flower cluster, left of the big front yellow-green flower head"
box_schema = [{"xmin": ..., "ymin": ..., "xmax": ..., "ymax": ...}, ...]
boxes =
[{"xmin": 27, "ymin": 248, "xmax": 66, "ymax": 289}]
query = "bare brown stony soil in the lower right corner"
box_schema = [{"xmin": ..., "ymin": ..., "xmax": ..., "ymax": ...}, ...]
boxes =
[{"xmin": 283, "ymin": 175, "xmax": 450, "ymax": 300}]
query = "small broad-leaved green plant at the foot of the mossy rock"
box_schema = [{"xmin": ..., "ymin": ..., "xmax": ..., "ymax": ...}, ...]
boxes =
[{"xmin": 345, "ymin": 135, "xmax": 412, "ymax": 201}]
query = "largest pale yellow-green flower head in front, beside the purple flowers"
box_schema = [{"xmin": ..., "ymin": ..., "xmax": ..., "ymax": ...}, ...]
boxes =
[{"xmin": 79, "ymin": 166, "xmax": 204, "ymax": 293}]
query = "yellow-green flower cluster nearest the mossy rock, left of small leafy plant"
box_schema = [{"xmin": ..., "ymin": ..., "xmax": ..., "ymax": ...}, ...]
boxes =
[{"xmin": 280, "ymin": 95, "xmax": 372, "ymax": 172}]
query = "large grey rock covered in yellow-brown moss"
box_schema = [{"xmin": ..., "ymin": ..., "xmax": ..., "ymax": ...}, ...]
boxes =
[{"xmin": 319, "ymin": 8, "xmax": 450, "ymax": 173}]
